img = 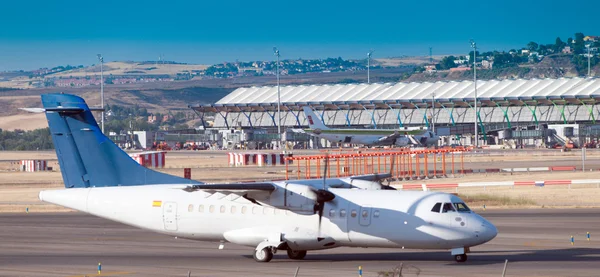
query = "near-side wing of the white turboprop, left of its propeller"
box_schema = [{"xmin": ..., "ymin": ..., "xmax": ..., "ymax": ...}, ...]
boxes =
[{"xmin": 183, "ymin": 183, "xmax": 276, "ymax": 201}]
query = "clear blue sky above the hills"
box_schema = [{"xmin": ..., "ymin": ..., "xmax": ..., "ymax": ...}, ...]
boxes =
[{"xmin": 0, "ymin": 0, "xmax": 600, "ymax": 71}]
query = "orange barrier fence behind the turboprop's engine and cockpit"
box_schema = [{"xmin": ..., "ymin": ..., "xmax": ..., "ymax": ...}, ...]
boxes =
[{"xmin": 285, "ymin": 148, "xmax": 470, "ymax": 180}]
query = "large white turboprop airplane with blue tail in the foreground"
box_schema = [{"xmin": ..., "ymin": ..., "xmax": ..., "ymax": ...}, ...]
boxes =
[{"xmin": 39, "ymin": 94, "xmax": 498, "ymax": 262}]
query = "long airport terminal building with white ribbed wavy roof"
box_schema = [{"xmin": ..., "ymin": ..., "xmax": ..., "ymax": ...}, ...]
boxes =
[{"xmin": 190, "ymin": 78, "xmax": 600, "ymax": 147}]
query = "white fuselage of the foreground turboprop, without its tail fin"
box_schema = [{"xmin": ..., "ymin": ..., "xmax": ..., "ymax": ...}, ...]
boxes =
[{"xmin": 40, "ymin": 185, "xmax": 497, "ymax": 250}]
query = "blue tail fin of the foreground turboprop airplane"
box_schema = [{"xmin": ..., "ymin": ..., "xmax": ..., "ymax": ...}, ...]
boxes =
[{"xmin": 42, "ymin": 94, "xmax": 198, "ymax": 188}]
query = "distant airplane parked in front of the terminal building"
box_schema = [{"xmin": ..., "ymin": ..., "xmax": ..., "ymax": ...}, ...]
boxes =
[{"xmin": 293, "ymin": 106, "xmax": 439, "ymax": 147}]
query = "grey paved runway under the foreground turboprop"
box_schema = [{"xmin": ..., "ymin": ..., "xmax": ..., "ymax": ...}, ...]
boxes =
[{"xmin": 0, "ymin": 209, "xmax": 600, "ymax": 276}]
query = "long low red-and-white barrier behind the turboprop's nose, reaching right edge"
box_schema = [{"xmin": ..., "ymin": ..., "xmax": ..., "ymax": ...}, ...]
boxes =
[{"xmin": 395, "ymin": 179, "xmax": 600, "ymax": 190}]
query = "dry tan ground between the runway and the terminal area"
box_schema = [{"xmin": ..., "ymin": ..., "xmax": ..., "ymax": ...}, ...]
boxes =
[{"xmin": 0, "ymin": 151, "xmax": 600, "ymax": 212}]
